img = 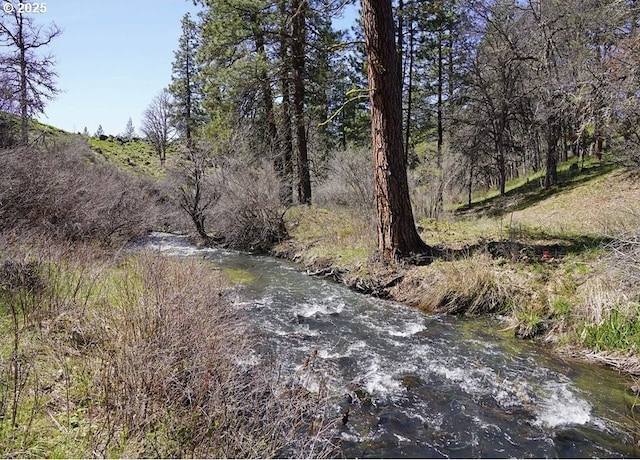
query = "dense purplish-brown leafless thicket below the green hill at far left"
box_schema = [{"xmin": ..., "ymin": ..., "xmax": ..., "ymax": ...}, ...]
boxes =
[{"xmin": 0, "ymin": 143, "xmax": 165, "ymax": 245}]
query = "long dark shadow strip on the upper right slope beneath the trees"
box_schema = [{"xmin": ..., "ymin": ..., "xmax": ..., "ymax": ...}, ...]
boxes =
[{"xmin": 456, "ymin": 163, "xmax": 617, "ymax": 217}]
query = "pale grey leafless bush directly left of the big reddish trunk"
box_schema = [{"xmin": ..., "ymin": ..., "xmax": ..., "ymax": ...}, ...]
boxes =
[{"xmin": 315, "ymin": 147, "xmax": 375, "ymax": 211}]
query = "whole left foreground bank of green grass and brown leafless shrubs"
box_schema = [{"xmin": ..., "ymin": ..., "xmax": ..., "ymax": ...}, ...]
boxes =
[{"xmin": 0, "ymin": 233, "xmax": 338, "ymax": 458}]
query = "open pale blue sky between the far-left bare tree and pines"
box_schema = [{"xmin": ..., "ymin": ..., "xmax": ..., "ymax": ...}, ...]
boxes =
[{"xmin": 35, "ymin": 0, "xmax": 198, "ymax": 135}]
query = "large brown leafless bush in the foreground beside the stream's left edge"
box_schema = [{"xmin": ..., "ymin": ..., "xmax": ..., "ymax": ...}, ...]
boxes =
[{"xmin": 96, "ymin": 255, "xmax": 338, "ymax": 458}]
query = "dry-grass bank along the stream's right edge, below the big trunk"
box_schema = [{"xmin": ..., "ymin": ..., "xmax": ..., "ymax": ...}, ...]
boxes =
[{"xmin": 271, "ymin": 238, "xmax": 640, "ymax": 380}]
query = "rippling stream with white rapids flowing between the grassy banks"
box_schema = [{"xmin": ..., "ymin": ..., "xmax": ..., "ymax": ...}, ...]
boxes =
[{"xmin": 142, "ymin": 234, "xmax": 640, "ymax": 457}]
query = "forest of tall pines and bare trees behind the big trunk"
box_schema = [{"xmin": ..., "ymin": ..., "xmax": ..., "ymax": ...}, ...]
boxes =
[{"xmin": 148, "ymin": 0, "xmax": 640, "ymax": 258}]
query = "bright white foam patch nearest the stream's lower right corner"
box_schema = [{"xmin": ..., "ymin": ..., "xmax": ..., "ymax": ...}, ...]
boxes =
[{"xmin": 533, "ymin": 382, "xmax": 593, "ymax": 428}]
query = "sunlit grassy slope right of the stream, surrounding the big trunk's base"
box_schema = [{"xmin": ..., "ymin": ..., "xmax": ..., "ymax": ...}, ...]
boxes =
[{"xmin": 276, "ymin": 163, "xmax": 640, "ymax": 374}]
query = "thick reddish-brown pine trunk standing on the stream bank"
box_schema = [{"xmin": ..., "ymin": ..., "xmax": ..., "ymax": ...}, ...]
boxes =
[{"xmin": 362, "ymin": 0, "xmax": 429, "ymax": 262}]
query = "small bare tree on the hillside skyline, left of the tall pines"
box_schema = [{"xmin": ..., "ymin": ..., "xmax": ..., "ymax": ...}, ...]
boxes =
[{"xmin": 141, "ymin": 89, "xmax": 175, "ymax": 168}]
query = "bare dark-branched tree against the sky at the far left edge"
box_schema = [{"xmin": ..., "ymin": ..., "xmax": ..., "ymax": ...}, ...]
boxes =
[{"xmin": 0, "ymin": 10, "xmax": 62, "ymax": 145}]
